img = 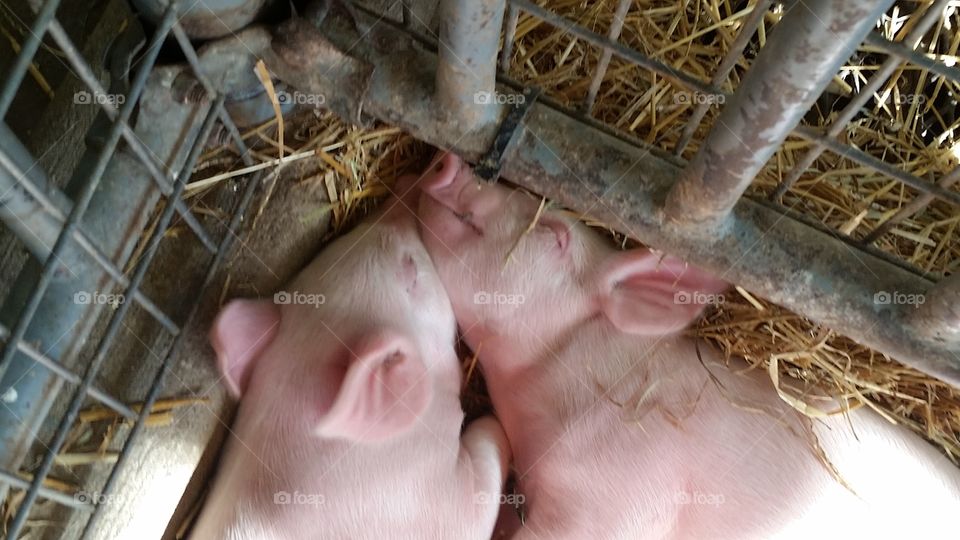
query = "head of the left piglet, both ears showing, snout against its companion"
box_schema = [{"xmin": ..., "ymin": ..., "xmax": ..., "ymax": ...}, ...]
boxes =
[{"xmin": 211, "ymin": 178, "xmax": 459, "ymax": 441}]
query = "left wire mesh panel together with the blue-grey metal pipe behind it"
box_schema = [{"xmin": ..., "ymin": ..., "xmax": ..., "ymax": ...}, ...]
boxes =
[{"xmin": 0, "ymin": 0, "xmax": 258, "ymax": 538}]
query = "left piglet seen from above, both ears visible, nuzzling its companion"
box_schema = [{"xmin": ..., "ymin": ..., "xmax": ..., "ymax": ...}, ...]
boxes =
[{"xmin": 193, "ymin": 174, "xmax": 509, "ymax": 540}]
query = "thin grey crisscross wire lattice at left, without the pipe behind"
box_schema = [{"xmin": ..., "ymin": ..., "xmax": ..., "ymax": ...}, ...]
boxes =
[{"xmin": 0, "ymin": 0, "xmax": 262, "ymax": 539}]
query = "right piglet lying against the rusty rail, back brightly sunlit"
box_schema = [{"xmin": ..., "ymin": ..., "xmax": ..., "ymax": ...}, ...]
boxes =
[{"xmin": 418, "ymin": 154, "xmax": 960, "ymax": 540}]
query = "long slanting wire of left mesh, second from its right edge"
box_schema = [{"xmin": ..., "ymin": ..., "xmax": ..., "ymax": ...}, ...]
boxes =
[{"xmin": 7, "ymin": 96, "xmax": 224, "ymax": 540}]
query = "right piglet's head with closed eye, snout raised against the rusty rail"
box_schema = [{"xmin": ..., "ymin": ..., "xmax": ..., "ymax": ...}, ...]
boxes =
[{"xmin": 419, "ymin": 153, "xmax": 726, "ymax": 354}]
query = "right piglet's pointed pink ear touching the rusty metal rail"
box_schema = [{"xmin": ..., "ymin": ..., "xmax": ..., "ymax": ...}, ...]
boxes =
[{"xmin": 600, "ymin": 249, "xmax": 727, "ymax": 335}]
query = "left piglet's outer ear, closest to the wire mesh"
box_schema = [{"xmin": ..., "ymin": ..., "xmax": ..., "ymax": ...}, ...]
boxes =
[{"xmin": 210, "ymin": 300, "xmax": 280, "ymax": 398}]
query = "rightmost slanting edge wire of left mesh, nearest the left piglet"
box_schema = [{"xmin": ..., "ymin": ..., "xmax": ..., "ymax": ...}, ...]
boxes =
[{"xmin": 80, "ymin": 117, "xmax": 263, "ymax": 540}]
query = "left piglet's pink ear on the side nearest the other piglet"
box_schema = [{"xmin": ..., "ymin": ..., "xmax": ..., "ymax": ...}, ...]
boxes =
[{"xmin": 316, "ymin": 333, "xmax": 433, "ymax": 441}]
